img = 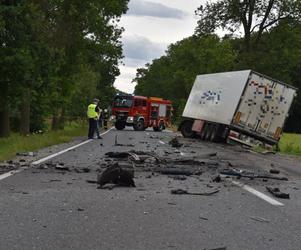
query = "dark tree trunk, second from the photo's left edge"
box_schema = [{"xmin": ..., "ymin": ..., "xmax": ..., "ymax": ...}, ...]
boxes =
[{"xmin": 20, "ymin": 88, "xmax": 30, "ymax": 135}]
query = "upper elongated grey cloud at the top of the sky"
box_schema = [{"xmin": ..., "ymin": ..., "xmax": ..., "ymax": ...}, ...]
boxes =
[{"xmin": 127, "ymin": 0, "xmax": 188, "ymax": 19}]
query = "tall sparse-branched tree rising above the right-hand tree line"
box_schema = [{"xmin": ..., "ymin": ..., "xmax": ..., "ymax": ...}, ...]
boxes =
[{"xmin": 196, "ymin": 0, "xmax": 301, "ymax": 51}]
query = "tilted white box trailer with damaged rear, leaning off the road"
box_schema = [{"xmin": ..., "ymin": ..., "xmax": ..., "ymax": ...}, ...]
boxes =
[{"xmin": 179, "ymin": 70, "xmax": 297, "ymax": 144}]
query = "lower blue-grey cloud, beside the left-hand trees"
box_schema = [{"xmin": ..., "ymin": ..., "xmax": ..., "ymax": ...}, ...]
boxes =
[{"xmin": 123, "ymin": 36, "xmax": 167, "ymax": 66}]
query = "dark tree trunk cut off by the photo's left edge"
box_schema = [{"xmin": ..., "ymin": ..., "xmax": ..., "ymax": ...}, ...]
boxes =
[{"xmin": 0, "ymin": 86, "xmax": 9, "ymax": 137}]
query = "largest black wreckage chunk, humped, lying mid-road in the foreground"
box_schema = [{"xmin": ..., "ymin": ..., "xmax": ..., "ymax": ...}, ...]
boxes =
[{"xmin": 97, "ymin": 162, "xmax": 136, "ymax": 188}]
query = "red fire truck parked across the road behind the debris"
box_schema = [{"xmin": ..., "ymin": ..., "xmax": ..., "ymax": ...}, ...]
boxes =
[{"xmin": 111, "ymin": 95, "xmax": 172, "ymax": 131}]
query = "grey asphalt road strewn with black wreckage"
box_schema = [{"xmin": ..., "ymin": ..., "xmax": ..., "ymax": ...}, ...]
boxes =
[{"xmin": 0, "ymin": 129, "xmax": 301, "ymax": 250}]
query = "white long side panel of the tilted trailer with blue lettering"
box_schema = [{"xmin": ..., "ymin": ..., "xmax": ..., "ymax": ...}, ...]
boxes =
[{"xmin": 183, "ymin": 70, "xmax": 251, "ymax": 125}]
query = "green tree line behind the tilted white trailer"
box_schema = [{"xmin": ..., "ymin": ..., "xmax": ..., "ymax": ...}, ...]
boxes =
[{"xmin": 134, "ymin": 0, "xmax": 301, "ymax": 132}]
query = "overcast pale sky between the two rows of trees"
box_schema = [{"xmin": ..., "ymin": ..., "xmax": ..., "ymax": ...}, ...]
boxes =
[{"xmin": 114, "ymin": 0, "xmax": 205, "ymax": 93}]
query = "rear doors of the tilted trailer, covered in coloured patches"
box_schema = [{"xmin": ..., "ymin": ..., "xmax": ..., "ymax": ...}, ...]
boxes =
[{"xmin": 234, "ymin": 72, "xmax": 296, "ymax": 140}]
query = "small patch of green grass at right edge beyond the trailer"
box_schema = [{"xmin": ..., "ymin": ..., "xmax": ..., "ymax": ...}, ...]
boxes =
[{"xmin": 279, "ymin": 133, "xmax": 301, "ymax": 156}]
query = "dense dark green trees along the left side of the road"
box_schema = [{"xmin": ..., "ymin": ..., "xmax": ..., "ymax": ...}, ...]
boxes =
[{"xmin": 0, "ymin": 0, "xmax": 128, "ymax": 137}]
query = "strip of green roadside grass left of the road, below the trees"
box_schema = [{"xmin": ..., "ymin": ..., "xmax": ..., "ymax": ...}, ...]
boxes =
[{"xmin": 0, "ymin": 122, "xmax": 87, "ymax": 161}]
